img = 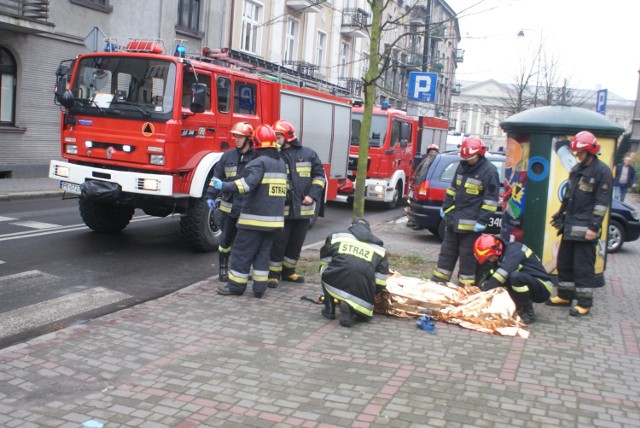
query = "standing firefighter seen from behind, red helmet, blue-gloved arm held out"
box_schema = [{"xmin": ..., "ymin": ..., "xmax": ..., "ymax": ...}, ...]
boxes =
[{"xmin": 212, "ymin": 125, "xmax": 287, "ymax": 298}]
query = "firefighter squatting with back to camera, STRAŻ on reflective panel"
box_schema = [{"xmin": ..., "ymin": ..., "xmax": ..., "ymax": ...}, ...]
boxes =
[{"xmin": 320, "ymin": 218, "xmax": 389, "ymax": 327}]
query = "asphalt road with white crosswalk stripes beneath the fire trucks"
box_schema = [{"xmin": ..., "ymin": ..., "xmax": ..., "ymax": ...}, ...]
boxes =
[{"xmin": 0, "ymin": 199, "xmax": 403, "ymax": 347}]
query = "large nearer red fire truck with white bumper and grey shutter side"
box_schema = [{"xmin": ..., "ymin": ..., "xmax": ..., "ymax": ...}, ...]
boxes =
[{"xmin": 49, "ymin": 39, "xmax": 351, "ymax": 251}]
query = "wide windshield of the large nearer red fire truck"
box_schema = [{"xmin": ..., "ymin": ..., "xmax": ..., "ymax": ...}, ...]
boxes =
[{"xmin": 71, "ymin": 56, "xmax": 176, "ymax": 118}]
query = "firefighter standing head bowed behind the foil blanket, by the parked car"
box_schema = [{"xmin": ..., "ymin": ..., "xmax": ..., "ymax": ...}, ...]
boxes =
[{"xmin": 431, "ymin": 137, "xmax": 500, "ymax": 287}]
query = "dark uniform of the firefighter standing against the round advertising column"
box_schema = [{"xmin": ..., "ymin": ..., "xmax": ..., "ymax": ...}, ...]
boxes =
[{"xmin": 556, "ymin": 157, "xmax": 613, "ymax": 309}]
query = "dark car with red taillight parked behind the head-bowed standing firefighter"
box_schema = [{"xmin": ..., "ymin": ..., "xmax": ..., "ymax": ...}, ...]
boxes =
[{"xmin": 405, "ymin": 150, "xmax": 505, "ymax": 239}]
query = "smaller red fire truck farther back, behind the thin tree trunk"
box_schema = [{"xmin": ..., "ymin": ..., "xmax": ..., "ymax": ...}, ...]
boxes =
[{"xmin": 339, "ymin": 105, "xmax": 449, "ymax": 208}]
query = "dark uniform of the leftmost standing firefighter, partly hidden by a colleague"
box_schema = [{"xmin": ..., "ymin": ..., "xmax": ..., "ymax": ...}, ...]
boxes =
[{"xmin": 205, "ymin": 146, "xmax": 255, "ymax": 258}]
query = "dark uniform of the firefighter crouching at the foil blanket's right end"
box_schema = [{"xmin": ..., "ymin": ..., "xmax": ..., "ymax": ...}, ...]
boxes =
[{"xmin": 478, "ymin": 242, "xmax": 553, "ymax": 308}]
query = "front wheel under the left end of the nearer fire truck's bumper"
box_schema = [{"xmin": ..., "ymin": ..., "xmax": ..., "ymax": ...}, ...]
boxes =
[{"xmin": 78, "ymin": 197, "xmax": 135, "ymax": 233}]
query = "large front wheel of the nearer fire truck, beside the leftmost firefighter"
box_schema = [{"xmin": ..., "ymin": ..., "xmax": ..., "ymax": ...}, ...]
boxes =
[{"xmin": 180, "ymin": 198, "xmax": 222, "ymax": 252}]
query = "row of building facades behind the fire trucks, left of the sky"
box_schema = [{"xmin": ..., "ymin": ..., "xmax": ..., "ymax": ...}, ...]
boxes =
[{"xmin": 0, "ymin": 0, "xmax": 462, "ymax": 178}]
